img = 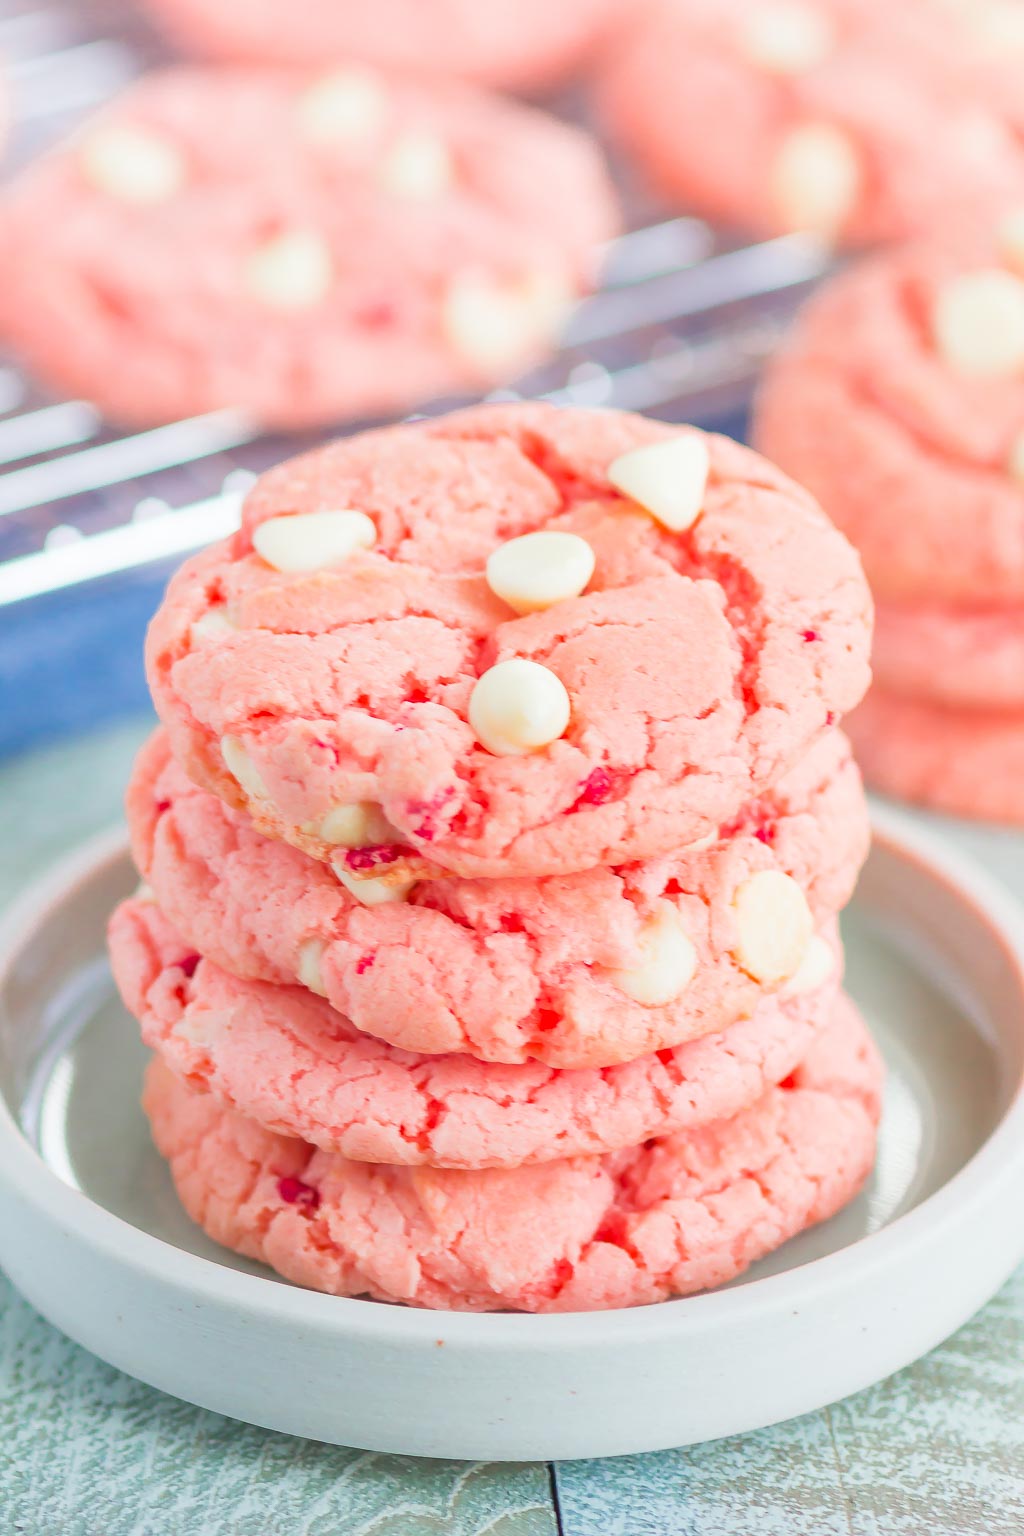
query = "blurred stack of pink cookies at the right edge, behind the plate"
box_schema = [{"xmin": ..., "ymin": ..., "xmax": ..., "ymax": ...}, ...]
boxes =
[{"xmin": 757, "ymin": 221, "xmax": 1024, "ymax": 825}]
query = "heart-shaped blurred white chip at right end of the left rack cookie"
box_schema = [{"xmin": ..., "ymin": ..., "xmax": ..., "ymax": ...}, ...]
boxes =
[{"xmin": 441, "ymin": 270, "xmax": 573, "ymax": 378}]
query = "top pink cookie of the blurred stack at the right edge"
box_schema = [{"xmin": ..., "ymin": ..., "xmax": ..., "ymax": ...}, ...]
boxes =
[{"xmin": 755, "ymin": 227, "xmax": 1024, "ymax": 611}]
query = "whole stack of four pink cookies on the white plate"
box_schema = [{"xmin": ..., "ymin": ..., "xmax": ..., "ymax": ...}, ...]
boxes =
[{"xmin": 111, "ymin": 406, "xmax": 880, "ymax": 1310}]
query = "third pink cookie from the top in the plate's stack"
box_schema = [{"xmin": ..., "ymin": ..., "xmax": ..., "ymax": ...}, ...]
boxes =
[{"xmin": 111, "ymin": 900, "xmax": 840, "ymax": 1167}]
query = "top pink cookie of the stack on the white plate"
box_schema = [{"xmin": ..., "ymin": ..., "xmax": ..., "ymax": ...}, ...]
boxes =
[{"xmin": 147, "ymin": 404, "xmax": 870, "ymax": 879}]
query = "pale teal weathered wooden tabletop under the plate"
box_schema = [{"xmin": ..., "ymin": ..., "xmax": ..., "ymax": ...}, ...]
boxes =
[{"xmin": 0, "ymin": 722, "xmax": 1024, "ymax": 1536}]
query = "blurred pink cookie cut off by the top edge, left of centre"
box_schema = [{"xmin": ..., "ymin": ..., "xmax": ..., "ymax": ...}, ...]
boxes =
[{"xmin": 147, "ymin": 0, "xmax": 622, "ymax": 91}]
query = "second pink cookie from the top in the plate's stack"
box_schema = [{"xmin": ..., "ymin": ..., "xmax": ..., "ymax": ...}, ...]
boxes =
[{"xmin": 127, "ymin": 731, "xmax": 869, "ymax": 1068}]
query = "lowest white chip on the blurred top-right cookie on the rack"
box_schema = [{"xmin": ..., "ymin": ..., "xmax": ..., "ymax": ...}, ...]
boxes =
[{"xmin": 771, "ymin": 123, "xmax": 861, "ymax": 240}]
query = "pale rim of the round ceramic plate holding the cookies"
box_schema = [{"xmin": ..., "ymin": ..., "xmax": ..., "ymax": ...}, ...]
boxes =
[{"xmin": 0, "ymin": 802, "xmax": 1024, "ymax": 1353}]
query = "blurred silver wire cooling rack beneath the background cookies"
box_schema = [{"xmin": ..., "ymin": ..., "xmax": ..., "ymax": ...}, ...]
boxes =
[{"xmin": 0, "ymin": 0, "xmax": 827, "ymax": 607}]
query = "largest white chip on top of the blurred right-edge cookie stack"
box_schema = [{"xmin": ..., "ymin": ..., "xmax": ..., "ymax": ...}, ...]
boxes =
[{"xmin": 932, "ymin": 267, "xmax": 1024, "ymax": 378}]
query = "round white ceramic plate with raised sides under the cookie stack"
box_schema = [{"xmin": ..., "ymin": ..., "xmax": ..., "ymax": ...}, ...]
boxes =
[{"xmin": 0, "ymin": 811, "xmax": 1024, "ymax": 1461}]
